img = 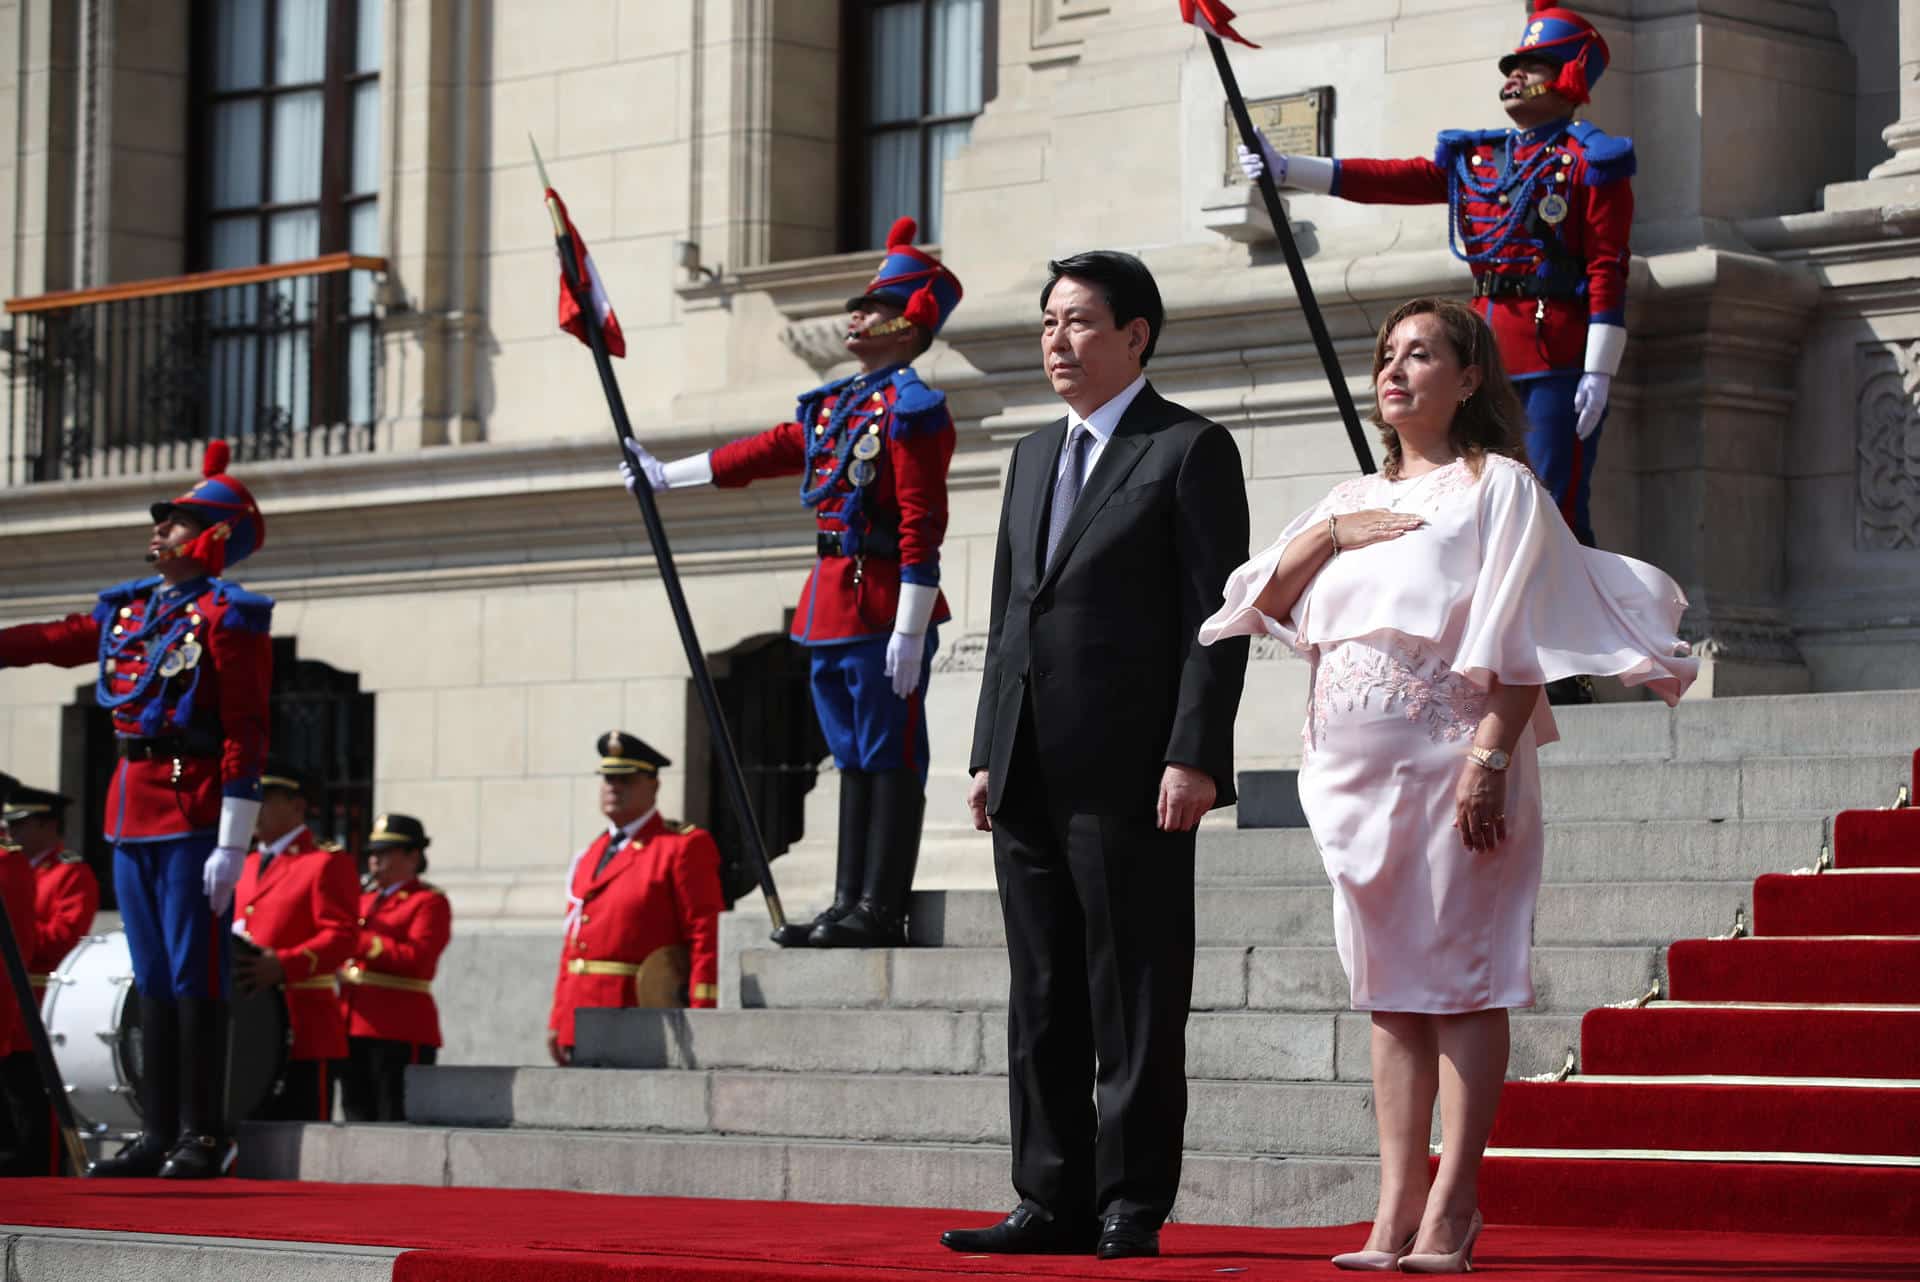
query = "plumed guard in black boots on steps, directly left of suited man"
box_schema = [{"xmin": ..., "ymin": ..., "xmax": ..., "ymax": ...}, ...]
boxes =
[{"xmin": 626, "ymin": 219, "xmax": 960, "ymax": 948}]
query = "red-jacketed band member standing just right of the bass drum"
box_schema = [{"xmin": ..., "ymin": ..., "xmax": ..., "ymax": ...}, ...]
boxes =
[{"xmin": 234, "ymin": 762, "xmax": 359, "ymax": 1121}]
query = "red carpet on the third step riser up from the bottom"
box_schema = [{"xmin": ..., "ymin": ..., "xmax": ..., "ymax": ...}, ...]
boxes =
[{"xmin": 1580, "ymin": 1004, "xmax": 1920, "ymax": 1079}]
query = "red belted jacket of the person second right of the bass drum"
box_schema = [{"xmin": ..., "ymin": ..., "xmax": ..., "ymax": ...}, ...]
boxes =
[{"xmin": 340, "ymin": 877, "xmax": 453, "ymax": 1046}]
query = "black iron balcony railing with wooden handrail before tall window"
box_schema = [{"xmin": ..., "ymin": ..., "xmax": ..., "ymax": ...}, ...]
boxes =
[{"xmin": 0, "ymin": 253, "xmax": 386, "ymax": 486}]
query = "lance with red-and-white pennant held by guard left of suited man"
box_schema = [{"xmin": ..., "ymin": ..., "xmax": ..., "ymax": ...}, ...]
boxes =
[{"xmin": 528, "ymin": 138, "xmax": 787, "ymax": 935}]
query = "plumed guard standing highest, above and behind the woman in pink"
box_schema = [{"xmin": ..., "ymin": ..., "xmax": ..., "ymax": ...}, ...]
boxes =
[{"xmin": 1240, "ymin": 0, "xmax": 1634, "ymax": 545}]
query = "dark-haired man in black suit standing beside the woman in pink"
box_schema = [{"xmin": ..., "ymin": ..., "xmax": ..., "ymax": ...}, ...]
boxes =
[{"xmin": 941, "ymin": 251, "xmax": 1248, "ymax": 1259}]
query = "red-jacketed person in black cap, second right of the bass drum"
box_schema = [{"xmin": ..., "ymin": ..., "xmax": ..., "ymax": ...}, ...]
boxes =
[{"xmin": 340, "ymin": 814, "xmax": 453, "ymax": 1121}]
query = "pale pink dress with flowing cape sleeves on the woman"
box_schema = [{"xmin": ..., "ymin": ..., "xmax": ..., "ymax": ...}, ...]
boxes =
[{"xmin": 1200, "ymin": 457, "xmax": 1699, "ymax": 1013}]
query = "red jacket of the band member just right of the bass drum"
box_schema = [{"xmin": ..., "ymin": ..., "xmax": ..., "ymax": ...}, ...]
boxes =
[{"xmin": 234, "ymin": 829, "xmax": 359, "ymax": 1059}]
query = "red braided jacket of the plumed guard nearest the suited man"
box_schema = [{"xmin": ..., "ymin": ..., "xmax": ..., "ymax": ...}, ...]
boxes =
[{"xmin": 708, "ymin": 368, "xmax": 956, "ymax": 645}]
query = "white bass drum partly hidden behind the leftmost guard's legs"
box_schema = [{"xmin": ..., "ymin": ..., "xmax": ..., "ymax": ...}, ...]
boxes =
[{"xmin": 40, "ymin": 931, "xmax": 294, "ymax": 1138}]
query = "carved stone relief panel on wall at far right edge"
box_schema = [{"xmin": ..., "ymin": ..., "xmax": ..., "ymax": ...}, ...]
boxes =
[{"xmin": 1853, "ymin": 342, "xmax": 1920, "ymax": 549}]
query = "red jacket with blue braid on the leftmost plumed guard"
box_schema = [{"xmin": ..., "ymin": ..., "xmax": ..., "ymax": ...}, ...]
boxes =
[{"xmin": 0, "ymin": 576, "xmax": 273, "ymax": 841}]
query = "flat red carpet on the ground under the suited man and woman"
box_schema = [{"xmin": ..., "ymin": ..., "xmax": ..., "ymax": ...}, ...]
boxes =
[{"xmin": 4, "ymin": 1182, "xmax": 1914, "ymax": 1282}]
